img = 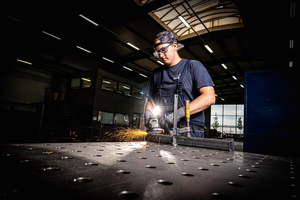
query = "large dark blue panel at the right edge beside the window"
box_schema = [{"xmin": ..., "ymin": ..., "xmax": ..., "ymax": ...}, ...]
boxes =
[{"xmin": 244, "ymin": 69, "xmax": 300, "ymax": 156}]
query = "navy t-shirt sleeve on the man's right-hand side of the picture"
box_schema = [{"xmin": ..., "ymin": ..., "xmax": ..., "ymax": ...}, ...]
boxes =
[{"xmin": 191, "ymin": 60, "xmax": 215, "ymax": 88}]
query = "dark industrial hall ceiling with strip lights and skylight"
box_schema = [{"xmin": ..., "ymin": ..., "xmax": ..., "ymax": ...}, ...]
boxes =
[{"xmin": 4, "ymin": 0, "xmax": 299, "ymax": 103}]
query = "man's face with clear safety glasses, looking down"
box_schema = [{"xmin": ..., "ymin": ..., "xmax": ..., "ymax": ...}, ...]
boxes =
[{"xmin": 155, "ymin": 42, "xmax": 177, "ymax": 66}]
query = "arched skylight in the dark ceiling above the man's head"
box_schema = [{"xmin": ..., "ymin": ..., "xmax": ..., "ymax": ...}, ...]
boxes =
[{"xmin": 148, "ymin": 0, "xmax": 244, "ymax": 40}]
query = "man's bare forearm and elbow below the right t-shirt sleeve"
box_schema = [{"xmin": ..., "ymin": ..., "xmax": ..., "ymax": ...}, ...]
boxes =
[{"xmin": 190, "ymin": 86, "xmax": 216, "ymax": 115}]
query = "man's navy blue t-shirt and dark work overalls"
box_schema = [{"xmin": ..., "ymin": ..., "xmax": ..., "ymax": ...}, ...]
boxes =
[{"xmin": 145, "ymin": 59, "xmax": 215, "ymax": 126}]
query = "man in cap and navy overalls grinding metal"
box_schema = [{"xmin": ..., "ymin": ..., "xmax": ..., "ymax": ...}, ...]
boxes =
[{"xmin": 145, "ymin": 31, "xmax": 215, "ymax": 138}]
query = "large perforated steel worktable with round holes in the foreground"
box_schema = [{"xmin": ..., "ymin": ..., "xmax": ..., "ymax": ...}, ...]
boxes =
[{"xmin": 0, "ymin": 140, "xmax": 300, "ymax": 200}]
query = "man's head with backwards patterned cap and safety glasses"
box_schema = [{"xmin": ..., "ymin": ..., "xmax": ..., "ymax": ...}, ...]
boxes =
[{"xmin": 153, "ymin": 31, "xmax": 184, "ymax": 66}]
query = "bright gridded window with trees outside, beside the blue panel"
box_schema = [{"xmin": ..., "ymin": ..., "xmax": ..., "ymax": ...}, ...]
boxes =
[{"xmin": 211, "ymin": 104, "xmax": 244, "ymax": 134}]
